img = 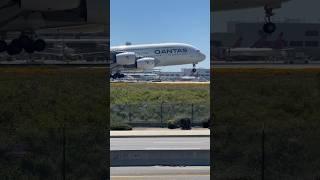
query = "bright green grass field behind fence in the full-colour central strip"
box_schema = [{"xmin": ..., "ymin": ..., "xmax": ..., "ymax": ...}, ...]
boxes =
[{"xmin": 111, "ymin": 83, "xmax": 210, "ymax": 123}]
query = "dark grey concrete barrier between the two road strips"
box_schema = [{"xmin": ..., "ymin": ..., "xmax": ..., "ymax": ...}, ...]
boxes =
[{"xmin": 110, "ymin": 149, "xmax": 210, "ymax": 167}]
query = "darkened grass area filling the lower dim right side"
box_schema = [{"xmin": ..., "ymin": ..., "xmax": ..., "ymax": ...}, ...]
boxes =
[{"xmin": 212, "ymin": 69, "xmax": 320, "ymax": 179}]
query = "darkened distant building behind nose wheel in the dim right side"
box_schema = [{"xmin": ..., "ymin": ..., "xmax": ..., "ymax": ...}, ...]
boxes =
[{"xmin": 211, "ymin": 21, "xmax": 320, "ymax": 60}]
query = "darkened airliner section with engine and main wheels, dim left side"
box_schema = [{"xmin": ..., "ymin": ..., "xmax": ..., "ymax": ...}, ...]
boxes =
[{"xmin": 0, "ymin": 0, "xmax": 109, "ymax": 55}]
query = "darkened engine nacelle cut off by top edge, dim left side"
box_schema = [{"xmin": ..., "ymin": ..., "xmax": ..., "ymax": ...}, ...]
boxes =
[{"xmin": 20, "ymin": 0, "xmax": 81, "ymax": 11}]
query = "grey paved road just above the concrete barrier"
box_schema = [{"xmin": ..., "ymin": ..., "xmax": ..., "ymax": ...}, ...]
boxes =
[{"xmin": 110, "ymin": 137, "xmax": 210, "ymax": 151}]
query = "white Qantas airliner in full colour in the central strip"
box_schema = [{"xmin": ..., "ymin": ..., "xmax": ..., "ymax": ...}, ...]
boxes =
[{"xmin": 110, "ymin": 43, "xmax": 206, "ymax": 78}]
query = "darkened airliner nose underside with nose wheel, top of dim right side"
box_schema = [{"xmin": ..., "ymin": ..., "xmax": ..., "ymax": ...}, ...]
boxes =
[{"xmin": 211, "ymin": 0, "xmax": 290, "ymax": 34}]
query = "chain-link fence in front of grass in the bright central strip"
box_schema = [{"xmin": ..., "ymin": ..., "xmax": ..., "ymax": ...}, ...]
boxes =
[{"xmin": 110, "ymin": 103, "xmax": 210, "ymax": 127}]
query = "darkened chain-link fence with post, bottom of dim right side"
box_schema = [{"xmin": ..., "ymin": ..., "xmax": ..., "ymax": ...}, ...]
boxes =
[{"xmin": 211, "ymin": 123, "xmax": 320, "ymax": 180}]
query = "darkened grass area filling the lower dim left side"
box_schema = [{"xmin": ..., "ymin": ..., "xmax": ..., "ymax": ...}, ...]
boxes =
[{"xmin": 0, "ymin": 67, "xmax": 109, "ymax": 179}]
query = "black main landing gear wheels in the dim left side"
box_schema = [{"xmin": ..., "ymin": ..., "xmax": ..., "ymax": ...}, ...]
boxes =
[{"xmin": 0, "ymin": 34, "xmax": 46, "ymax": 55}]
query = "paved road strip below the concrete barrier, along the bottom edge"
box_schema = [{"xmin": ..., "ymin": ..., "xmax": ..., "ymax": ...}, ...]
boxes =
[{"xmin": 111, "ymin": 166, "xmax": 210, "ymax": 180}]
